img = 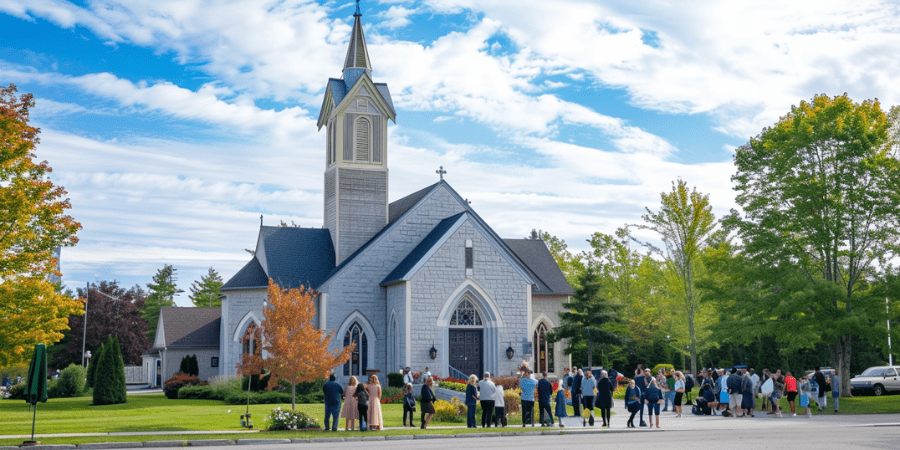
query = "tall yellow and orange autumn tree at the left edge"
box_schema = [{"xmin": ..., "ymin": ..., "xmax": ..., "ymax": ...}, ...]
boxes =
[{"xmin": 0, "ymin": 84, "xmax": 84, "ymax": 367}]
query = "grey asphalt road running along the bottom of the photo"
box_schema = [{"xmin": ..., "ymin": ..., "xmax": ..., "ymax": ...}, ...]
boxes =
[{"xmin": 179, "ymin": 414, "xmax": 900, "ymax": 450}]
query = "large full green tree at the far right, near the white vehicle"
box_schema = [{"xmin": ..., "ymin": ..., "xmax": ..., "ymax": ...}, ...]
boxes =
[{"xmin": 726, "ymin": 94, "xmax": 900, "ymax": 395}]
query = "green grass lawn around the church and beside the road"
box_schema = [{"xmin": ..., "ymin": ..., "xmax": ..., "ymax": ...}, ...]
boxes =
[{"xmin": 0, "ymin": 394, "xmax": 897, "ymax": 445}]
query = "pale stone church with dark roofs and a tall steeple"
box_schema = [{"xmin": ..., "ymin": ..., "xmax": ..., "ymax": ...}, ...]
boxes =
[{"xmin": 217, "ymin": 10, "xmax": 573, "ymax": 380}]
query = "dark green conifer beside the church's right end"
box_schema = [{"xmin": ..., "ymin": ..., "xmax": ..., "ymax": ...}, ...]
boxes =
[{"xmin": 547, "ymin": 265, "xmax": 623, "ymax": 366}]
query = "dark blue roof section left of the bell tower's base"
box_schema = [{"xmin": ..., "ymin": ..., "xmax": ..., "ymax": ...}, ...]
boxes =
[{"xmin": 222, "ymin": 226, "xmax": 334, "ymax": 291}]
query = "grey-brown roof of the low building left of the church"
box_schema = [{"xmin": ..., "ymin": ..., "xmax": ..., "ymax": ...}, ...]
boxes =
[{"xmin": 159, "ymin": 306, "xmax": 222, "ymax": 348}]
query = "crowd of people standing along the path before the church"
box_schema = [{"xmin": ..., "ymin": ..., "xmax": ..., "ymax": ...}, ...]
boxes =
[{"xmin": 323, "ymin": 365, "xmax": 841, "ymax": 431}]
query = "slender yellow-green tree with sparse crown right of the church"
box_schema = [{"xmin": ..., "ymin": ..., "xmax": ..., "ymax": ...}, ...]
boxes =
[{"xmin": 636, "ymin": 179, "xmax": 716, "ymax": 373}]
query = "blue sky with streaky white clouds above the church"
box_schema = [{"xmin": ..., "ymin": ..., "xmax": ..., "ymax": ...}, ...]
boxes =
[{"xmin": 0, "ymin": 0, "xmax": 900, "ymax": 306}]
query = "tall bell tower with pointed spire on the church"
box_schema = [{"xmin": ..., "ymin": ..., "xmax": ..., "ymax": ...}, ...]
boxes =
[{"xmin": 318, "ymin": 0, "xmax": 396, "ymax": 264}]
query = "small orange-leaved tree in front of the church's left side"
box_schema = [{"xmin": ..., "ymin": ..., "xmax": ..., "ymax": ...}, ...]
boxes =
[{"xmin": 262, "ymin": 279, "xmax": 353, "ymax": 410}]
